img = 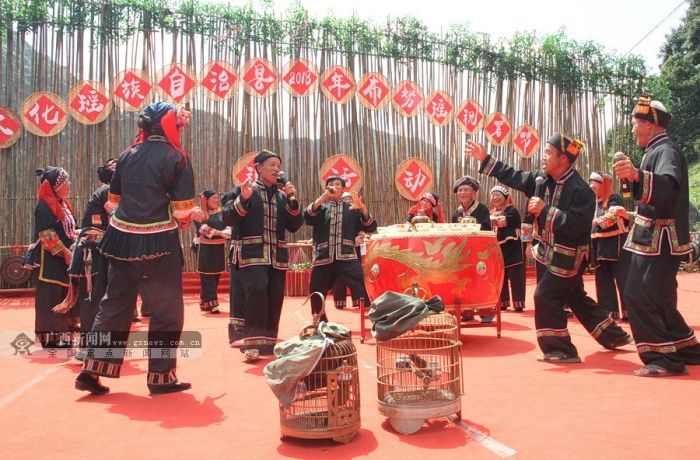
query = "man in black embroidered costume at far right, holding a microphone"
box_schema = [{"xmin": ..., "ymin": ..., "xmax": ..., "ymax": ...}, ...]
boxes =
[{"xmin": 613, "ymin": 95, "xmax": 700, "ymax": 377}]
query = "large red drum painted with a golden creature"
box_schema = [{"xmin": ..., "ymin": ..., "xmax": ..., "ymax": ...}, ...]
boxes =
[{"xmin": 364, "ymin": 224, "xmax": 505, "ymax": 309}]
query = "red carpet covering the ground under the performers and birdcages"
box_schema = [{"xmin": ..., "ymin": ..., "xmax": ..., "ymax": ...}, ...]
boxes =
[{"xmin": 0, "ymin": 273, "xmax": 700, "ymax": 460}]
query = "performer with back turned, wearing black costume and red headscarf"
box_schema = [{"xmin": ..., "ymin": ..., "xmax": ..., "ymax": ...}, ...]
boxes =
[{"xmin": 75, "ymin": 102, "xmax": 204, "ymax": 395}]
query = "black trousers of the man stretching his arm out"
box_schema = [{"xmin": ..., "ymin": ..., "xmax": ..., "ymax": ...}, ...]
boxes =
[{"xmin": 535, "ymin": 262, "xmax": 627, "ymax": 356}]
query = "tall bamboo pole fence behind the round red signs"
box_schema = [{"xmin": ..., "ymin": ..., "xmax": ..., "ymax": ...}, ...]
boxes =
[{"xmin": 0, "ymin": 6, "xmax": 636, "ymax": 271}]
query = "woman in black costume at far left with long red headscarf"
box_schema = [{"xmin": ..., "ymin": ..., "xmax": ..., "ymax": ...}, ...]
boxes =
[{"xmin": 24, "ymin": 166, "xmax": 77, "ymax": 348}]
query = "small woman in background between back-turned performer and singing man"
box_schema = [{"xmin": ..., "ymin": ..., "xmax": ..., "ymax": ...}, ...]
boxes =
[{"xmin": 195, "ymin": 188, "xmax": 231, "ymax": 315}]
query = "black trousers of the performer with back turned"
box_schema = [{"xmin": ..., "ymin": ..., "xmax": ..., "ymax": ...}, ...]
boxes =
[{"xmin": 83, "ymin": 246, "xmax": 184, "ymax": 385}]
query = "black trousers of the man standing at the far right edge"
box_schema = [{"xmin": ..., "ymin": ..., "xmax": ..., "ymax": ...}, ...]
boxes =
[{"xmin": 624, "ymin": 243, "xmax": 700, "ymax": 372}]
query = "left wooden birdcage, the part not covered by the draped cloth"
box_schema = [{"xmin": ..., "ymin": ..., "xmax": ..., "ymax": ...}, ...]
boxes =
[{"xmin": 280, "ymin": 293, "xmax": 360, "ymax": 443}]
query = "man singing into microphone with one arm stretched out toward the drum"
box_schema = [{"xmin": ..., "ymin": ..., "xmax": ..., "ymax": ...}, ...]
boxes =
[{"xmin": 465, "ymin": 133, "xmax": 632, "ymax": 363}]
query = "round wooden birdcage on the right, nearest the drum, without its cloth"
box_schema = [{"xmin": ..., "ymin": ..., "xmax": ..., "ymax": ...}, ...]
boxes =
[{"xmin": 377, "ymin": 312, "xmax": 463, "ymax": 434}]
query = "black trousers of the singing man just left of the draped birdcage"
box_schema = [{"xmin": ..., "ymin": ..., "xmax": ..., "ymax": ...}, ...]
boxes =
[{"xmin": 238, "ymin": 265, "xmax": 287, "ymax": 355}]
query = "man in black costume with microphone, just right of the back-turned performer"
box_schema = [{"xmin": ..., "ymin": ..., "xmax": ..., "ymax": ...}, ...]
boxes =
[{"xmin": 222, "ymin": 150, "xmax": 304, "ymax": 361}]
